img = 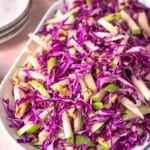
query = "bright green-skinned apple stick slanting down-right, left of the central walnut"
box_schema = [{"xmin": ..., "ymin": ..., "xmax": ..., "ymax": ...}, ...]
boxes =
[{"xmin": 29, "ymin": 80, "xmax": 50, "ymax": 98}]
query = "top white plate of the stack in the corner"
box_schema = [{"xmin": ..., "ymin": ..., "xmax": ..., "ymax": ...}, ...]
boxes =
[{"xmin": 0, "ymin": 0, "xmax": 30, "ymax": 30}]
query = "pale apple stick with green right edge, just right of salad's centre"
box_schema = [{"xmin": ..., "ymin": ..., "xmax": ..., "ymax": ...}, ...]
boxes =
[{"xmin": 84, "ymin": 73, "xmax": 96, "ymax": 91}]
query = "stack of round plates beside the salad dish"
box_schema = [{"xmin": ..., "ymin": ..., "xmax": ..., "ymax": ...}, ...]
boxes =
[{"xmin": 0, "ymin": 0, "xmax": 31, "ymax": 43}]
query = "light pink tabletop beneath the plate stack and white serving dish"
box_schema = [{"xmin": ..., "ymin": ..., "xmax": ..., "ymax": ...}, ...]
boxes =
[{"xmin": 0, "ymin": 0, "xmax": 55, "ymax": 150}]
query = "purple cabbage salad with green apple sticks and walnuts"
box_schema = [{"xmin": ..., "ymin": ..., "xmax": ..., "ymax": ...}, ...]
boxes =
[{"xmin": 3, "ymin": 0, "xmax": 150, "ymax": 150}]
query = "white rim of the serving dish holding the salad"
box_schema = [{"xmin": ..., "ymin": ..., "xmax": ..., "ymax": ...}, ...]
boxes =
[{"xmin": 0, "ymin": 0, "xmax": 149, "ymax": 150}]
